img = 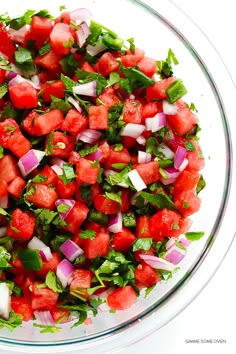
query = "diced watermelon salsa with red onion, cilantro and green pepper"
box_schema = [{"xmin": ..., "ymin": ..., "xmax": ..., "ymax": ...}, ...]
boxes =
[{"xmin": 0, "ymin": 5, "xmax": 205, "ymax": 332}]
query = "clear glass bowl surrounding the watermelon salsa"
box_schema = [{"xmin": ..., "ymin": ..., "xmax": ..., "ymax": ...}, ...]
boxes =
[{"xmin": 0, "ymin": 0, "xmax": 236, "ymax": 353}]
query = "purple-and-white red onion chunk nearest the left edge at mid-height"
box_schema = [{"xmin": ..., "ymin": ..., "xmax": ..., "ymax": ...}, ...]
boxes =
[{"xmin": 18, "ymin": 149, "xmax": 45, "ymax": 177}]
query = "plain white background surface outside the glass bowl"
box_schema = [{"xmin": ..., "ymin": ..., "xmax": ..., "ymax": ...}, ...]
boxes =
[{"xmin": 1, "ymin": 0, "xmax": 236, "ymax": 354}]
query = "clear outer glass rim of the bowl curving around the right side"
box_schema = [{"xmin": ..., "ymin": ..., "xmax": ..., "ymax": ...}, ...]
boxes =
[{"xmin": 0, "ymin": 0, "xmax": 236, "ymax": 353}]
